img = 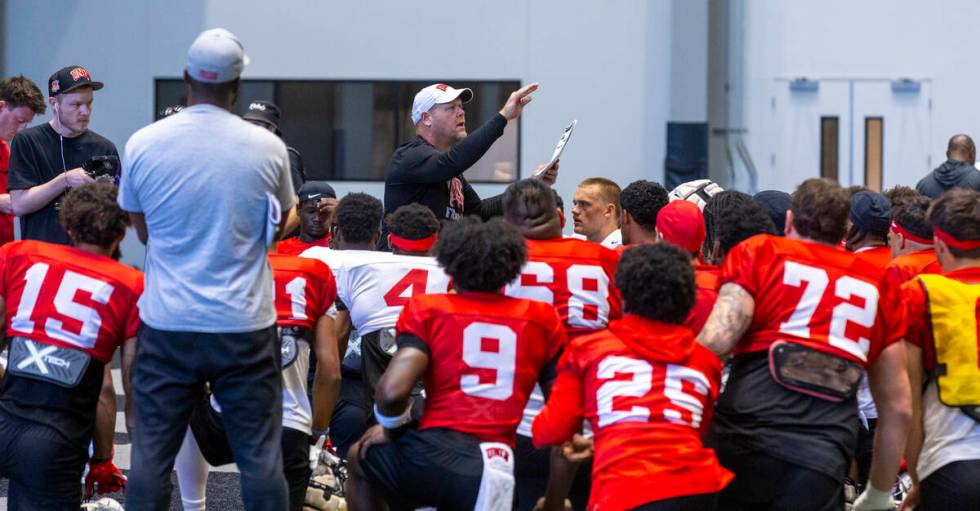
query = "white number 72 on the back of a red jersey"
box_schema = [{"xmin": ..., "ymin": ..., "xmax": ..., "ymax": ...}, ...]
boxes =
[{"xmin": 779, "ymin": 261, "xmax": 878, "ymax": 361}]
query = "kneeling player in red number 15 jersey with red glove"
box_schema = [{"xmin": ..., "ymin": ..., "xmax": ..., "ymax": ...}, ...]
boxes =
[{"xmin": 0, "ymin": 183, "xmax": 143, "ymax": 510}]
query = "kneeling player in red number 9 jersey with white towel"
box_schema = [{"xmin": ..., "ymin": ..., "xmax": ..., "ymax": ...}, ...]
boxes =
[{"xmin": 347, "ymin": 220, "xmax": 565, "ymax": 511}]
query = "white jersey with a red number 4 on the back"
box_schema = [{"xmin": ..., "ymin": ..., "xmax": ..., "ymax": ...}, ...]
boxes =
[{"xmin": 302, "ymin": 247, "xmax": 449, "ymax": 335}]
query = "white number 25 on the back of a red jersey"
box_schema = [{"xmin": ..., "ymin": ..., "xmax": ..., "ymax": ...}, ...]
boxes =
[{"xmin": 596, "ymin": 355, "xmax": 711, "ymax": 429}]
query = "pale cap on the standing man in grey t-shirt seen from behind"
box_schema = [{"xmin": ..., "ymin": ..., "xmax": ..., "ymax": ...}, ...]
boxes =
[{"xmin": 187, "ymin": 28, "xmax": 248, "ymax": 83}]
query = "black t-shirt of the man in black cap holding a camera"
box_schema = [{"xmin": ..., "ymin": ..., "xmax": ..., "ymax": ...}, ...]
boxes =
[{"xmin": 7, "ymin": 123, "xmax": 119, "ymax": 245}]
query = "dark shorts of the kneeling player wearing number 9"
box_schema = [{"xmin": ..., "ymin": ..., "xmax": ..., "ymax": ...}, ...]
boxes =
[{"xmin": 360, "ymin": 428, "xmax": 483, "ymax": 511}]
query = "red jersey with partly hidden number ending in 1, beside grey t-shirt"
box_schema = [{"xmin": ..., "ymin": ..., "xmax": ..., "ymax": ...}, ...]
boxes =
[{"xmin": 269, "ymin": 253, "xmax": 337, "ymax": 330}]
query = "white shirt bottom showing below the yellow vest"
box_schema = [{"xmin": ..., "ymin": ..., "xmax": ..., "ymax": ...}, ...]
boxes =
[{"xmin": 918, "ymin": 380, "xmax": 980, "ymax": 480}]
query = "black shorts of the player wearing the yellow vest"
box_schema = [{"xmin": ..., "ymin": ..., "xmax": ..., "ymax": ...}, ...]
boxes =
[{"xmin": 916, "ymin": 460, "xmax": 980, "ymax": 511}]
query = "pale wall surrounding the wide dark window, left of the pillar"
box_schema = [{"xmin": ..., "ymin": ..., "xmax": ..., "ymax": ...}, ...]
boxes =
[{"xmin": 2, "ymin": 0, "xmax": 672, "ymax": 264}]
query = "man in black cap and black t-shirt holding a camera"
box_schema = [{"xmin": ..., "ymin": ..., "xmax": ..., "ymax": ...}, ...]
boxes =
[{"xmin": 7, "ymin": 66, "xmax": 119, "ymax": 245}]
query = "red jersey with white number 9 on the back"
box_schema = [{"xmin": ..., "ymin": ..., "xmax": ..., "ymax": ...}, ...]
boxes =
[{"xmin": 395, "ymin": 292, "xmax": 566, "ymax": 446}]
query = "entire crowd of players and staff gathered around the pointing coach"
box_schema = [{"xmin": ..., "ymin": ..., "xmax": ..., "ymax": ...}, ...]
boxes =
[{"xmin": 0, "ymin": 29, "xmax": 980, "ymax": 511}]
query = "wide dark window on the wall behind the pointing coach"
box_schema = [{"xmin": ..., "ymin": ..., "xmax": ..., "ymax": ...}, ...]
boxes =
[{"xmin": 155, "ymin": 78, "xmax": 520, "ymax": 183}]
